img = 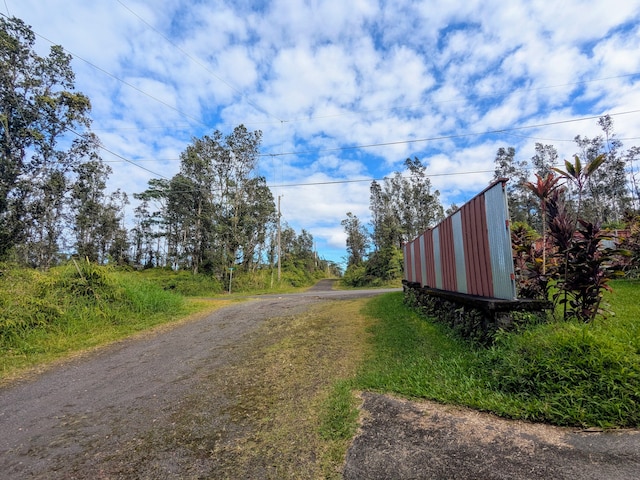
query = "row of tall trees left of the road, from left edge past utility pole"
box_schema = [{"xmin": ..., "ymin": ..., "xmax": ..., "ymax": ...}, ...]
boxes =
[{"xmin": 0, "ymin": 18, "xmax": 337, "ymax": 275}]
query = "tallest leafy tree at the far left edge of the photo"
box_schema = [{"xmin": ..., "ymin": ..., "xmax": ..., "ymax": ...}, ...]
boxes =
[{"xmin": 0, "ymin": 18, "xmax": 93, "ymax": 260}]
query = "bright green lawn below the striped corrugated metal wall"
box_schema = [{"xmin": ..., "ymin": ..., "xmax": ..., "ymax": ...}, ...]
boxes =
[{"xmin": 354, "ymin": 281, "xmax": 640, "ymax": 427}]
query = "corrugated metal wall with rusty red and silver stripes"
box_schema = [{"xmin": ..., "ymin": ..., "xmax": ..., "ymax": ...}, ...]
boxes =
[{"xmin": 403, "ymin": 179, "xmax": 516, "ymax": 299}]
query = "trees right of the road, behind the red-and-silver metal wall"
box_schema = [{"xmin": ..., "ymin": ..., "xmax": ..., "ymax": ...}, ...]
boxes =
[{"xmin": 342, "ymin": 115, "xmax": 640, "ymax": 288}]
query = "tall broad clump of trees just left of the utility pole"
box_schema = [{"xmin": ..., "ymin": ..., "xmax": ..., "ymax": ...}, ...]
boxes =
[{"xmin": 151, "ymin": 125, "xmax": 275, "ymax": 275}]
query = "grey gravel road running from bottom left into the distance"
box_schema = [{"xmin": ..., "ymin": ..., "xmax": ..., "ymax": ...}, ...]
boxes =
[{"xmin": 0, "ymin": 281, "xmax": 392, "ymax": 480}]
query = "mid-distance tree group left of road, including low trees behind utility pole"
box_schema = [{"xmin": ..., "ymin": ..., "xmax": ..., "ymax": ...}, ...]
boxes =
[{"xmin": 131, "ymin": 125, "xmax": 335, "ymax": 273}]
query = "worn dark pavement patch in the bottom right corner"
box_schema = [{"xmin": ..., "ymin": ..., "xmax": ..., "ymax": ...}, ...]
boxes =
[{"xmin": 344, "ymin": 392, "xmax": 640, "ymax": 480}]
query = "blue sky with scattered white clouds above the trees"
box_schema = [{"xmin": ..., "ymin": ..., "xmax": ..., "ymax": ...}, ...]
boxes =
[{"xmin": 5, "ymin": 0, "xmax": 640, "ymax": 262}]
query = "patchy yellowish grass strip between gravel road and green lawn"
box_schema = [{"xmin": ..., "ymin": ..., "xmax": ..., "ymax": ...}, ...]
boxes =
[{"xmin": 123, "ymin": 300, "xmax": 368, "ymax": 479}]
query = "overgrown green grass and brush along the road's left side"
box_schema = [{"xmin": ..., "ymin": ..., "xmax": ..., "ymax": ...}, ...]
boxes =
[{"xmin": 0, "ymin": 260, "xmax": 328, "ymax": 382}]
